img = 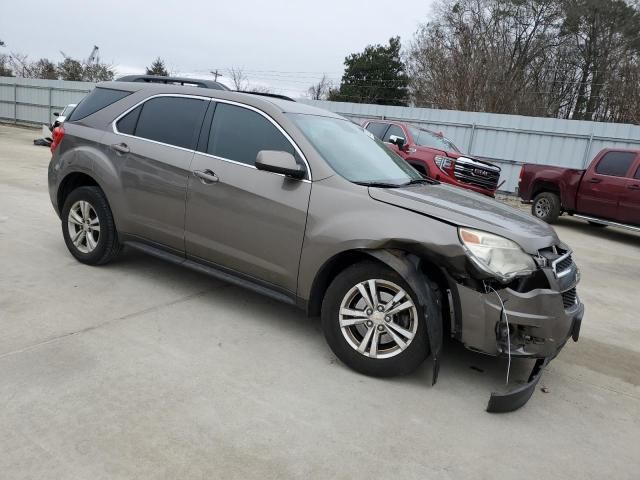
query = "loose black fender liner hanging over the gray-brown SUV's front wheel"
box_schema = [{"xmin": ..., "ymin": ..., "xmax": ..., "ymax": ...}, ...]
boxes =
[{"xmin": 364, "ymin": 250, "xmax": 443, "ymax": 385}]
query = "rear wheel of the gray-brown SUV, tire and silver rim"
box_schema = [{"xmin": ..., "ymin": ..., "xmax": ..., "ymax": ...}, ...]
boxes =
[{"xmin": 61, "ymin": 187, "xmax": 120, "ymax": 265}]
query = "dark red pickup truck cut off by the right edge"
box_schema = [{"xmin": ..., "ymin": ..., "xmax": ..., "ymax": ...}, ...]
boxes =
[{"xmin": 518, "ymin": 149, "xmax": 640, "ymax": 230}]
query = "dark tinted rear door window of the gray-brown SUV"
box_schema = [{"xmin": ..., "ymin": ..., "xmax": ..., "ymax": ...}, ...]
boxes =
[{"xmin": 135, "ymin": 97, "xmax": 207, "ymax": 148}]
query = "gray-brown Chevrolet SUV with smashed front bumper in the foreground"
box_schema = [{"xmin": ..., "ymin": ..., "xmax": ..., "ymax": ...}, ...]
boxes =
[{"xmin": 49, "ymin": 81, "xmax": 584, "ymax": 411}]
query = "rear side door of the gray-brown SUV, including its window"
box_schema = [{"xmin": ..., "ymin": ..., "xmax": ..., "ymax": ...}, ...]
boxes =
[{"xmin": 103, "ymin": 95, "xmax": 209, "ymax": 253}]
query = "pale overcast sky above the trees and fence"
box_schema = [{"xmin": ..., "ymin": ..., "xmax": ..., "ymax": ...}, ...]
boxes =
[{"xmin": 0, "ymin": 0, "xmax": 432, "ymax": 95}]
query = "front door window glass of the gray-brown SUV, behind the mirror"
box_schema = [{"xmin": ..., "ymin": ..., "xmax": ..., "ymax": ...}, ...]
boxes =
[{"xmin": 207, "ymin": 103, "xmax": 295, "ymax": 165}]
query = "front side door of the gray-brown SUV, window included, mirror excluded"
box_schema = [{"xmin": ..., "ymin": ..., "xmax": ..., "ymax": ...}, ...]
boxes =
[{"xmin": 185, "ymin": 101, "xmax": 311, "ymax": 293}]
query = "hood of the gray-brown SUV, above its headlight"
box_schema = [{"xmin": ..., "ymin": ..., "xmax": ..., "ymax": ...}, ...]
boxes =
[{"xmin": 369, "ymin": 184, "xmax": 560, "ymax": 255}]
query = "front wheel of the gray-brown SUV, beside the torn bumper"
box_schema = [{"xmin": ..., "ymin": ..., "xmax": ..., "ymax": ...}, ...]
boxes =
[{"xmin": 322, "ymin": 261, "xmax": 429, "ymax": 377}]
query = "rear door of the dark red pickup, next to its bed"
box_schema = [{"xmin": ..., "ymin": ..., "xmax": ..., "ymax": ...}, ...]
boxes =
[{"xmin": 577, "ymin": 151, "xmax": 636, "ymax": 220}]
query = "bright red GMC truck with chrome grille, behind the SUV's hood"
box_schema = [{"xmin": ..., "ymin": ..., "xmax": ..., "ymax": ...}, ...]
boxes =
[{"xmin": 364, "ymin": 120, "xmax": 500, "ymax": 197}]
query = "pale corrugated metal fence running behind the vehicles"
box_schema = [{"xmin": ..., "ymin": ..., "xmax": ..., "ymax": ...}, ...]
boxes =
[{"xmin": 0, "ymin": 77, "xmax": 640, "ymax": 192}]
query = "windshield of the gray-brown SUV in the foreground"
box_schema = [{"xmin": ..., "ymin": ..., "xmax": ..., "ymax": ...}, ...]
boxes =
[{"xmin": 289, "ymin": 114, "xmax": 422, "ymax": 185}]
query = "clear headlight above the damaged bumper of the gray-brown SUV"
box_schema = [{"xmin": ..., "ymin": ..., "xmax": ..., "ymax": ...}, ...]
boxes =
[{"xmin": 458, "ymin": 228, "xmax": 536, "ymax": 283}]
